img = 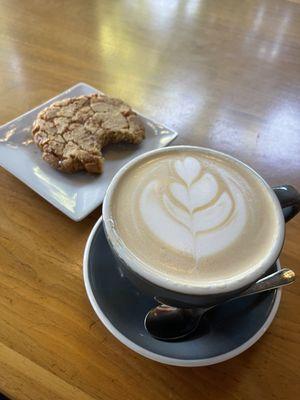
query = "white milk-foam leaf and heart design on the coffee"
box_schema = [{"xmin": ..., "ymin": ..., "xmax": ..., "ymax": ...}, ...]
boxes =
[{"xmin": 139, "ymin": 156, "xmax": 247, "ymax": 267}]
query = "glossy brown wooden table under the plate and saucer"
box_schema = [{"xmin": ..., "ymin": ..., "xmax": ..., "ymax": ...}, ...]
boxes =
[{"xmin": 0, "ymin": 0, "xmax": 300, "ymax": 400}]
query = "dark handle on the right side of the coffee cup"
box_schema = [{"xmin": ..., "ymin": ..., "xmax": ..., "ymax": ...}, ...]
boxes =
[{"xmin": 272, "ymin": 185, "xmax": 300, "ymax": 222}]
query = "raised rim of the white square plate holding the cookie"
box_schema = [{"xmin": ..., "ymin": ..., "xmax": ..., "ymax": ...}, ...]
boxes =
[{"xmin": 0, "ymin": 82, "xmax": 178, "ymax": 222}]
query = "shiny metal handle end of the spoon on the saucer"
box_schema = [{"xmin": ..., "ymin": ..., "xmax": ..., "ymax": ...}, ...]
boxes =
[{"xmin": 238, "ymin": 268, "xmax": 295, "ymax": 297}]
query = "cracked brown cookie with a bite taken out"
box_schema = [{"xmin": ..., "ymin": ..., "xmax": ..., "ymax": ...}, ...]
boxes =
[{"xmin": 32, "ymin": 93, "xmax": 145, "ymax": 173}]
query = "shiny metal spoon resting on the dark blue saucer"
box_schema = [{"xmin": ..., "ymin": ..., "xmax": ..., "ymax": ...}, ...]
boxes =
[{"xmin": 144, "ymin": 268, "xmax": 295, "ymax": 341}]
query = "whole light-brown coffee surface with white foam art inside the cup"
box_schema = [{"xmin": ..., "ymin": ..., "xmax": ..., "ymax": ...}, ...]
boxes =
[{"xmin": 110, "ymin": 150, "xmax": 279, "ymax": 285}]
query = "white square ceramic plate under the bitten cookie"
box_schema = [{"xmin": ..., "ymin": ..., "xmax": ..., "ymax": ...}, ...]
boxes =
[{"xmin": 0, "ymin": 83, "xmax": 177, "ymax": 221}]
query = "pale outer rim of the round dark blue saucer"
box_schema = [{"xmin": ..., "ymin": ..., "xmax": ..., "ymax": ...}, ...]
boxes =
[{"xmin": 83, "ymin": 216, "xmax": 282, "ymax": 367}]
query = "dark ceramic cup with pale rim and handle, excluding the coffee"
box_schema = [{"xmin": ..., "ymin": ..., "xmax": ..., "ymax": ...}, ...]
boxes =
[{"xmin": 103, "ymin": 146, "xmax": 300, "ymax": 307}]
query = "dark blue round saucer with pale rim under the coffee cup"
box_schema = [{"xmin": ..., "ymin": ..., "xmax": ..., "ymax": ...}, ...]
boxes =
[{"xmin": 84, "ymin": 218, "xmax": 281, "ymax": 366}]
